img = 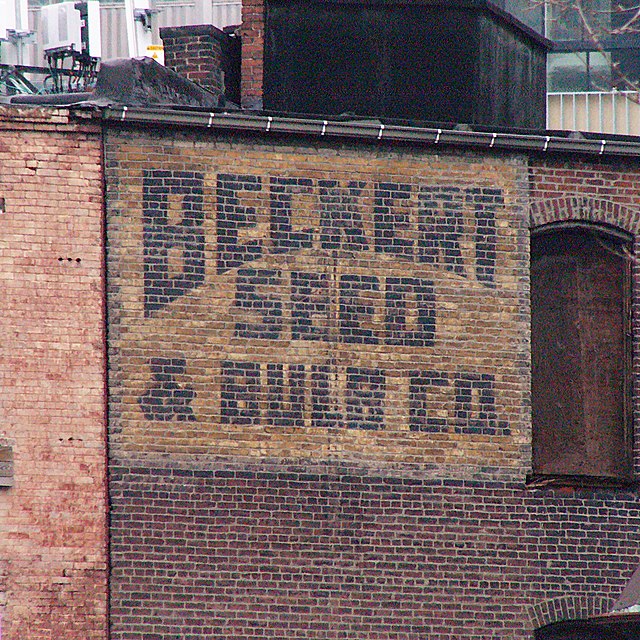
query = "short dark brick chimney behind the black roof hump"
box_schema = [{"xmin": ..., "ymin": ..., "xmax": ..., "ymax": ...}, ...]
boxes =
[{"xmin": 160, "ymin": 25, "xmax": 240, "ymax": 104}]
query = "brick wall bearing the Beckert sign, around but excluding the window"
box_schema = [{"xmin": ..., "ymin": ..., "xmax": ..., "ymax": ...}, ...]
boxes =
[{"xmin": 101, "ymin": 124, "xmax": 638, "ymax": 639}]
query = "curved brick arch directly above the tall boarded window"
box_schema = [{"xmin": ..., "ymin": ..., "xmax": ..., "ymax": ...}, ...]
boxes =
[{"xmin": 529, "ymin": 195, "xmax": 640, "ymax": 237}]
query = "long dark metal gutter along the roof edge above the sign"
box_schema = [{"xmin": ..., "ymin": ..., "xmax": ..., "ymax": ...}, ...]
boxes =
[{"xmin": 102, "ymin": 106, "xmax": 640, "ymax": 157}]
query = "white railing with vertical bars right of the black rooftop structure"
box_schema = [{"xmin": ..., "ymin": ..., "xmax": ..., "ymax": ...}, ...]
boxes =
[{"xmin": 547, "ymin": 91, "xmax": 640, "ymax": 136}]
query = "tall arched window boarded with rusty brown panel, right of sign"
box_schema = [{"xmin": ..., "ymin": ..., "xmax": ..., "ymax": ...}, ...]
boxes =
[{"xmin": 531, "ymin": 225, "xmax": 631, "ymax": 479}]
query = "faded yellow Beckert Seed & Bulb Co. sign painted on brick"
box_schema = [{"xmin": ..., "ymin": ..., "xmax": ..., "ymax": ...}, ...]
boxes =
[{"xmin": 114, "ymin": 140, "xmax": 522, "ymax": 468}]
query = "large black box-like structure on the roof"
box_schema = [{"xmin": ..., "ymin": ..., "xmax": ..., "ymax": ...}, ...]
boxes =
[{"xmin": 262, "ymin": 0, "xmax": 550, "ymax": 128}]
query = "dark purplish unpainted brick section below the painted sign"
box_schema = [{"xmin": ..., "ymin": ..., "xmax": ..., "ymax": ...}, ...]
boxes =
[{"xmin": 111, "ymin": 464, "xmax": 640, "ymax": 640}]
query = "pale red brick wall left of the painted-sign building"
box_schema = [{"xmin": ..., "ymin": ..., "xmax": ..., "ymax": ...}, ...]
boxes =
[{"xmin": 0, "ymin": 108, "xmax": 107, "ymax": 640}]
